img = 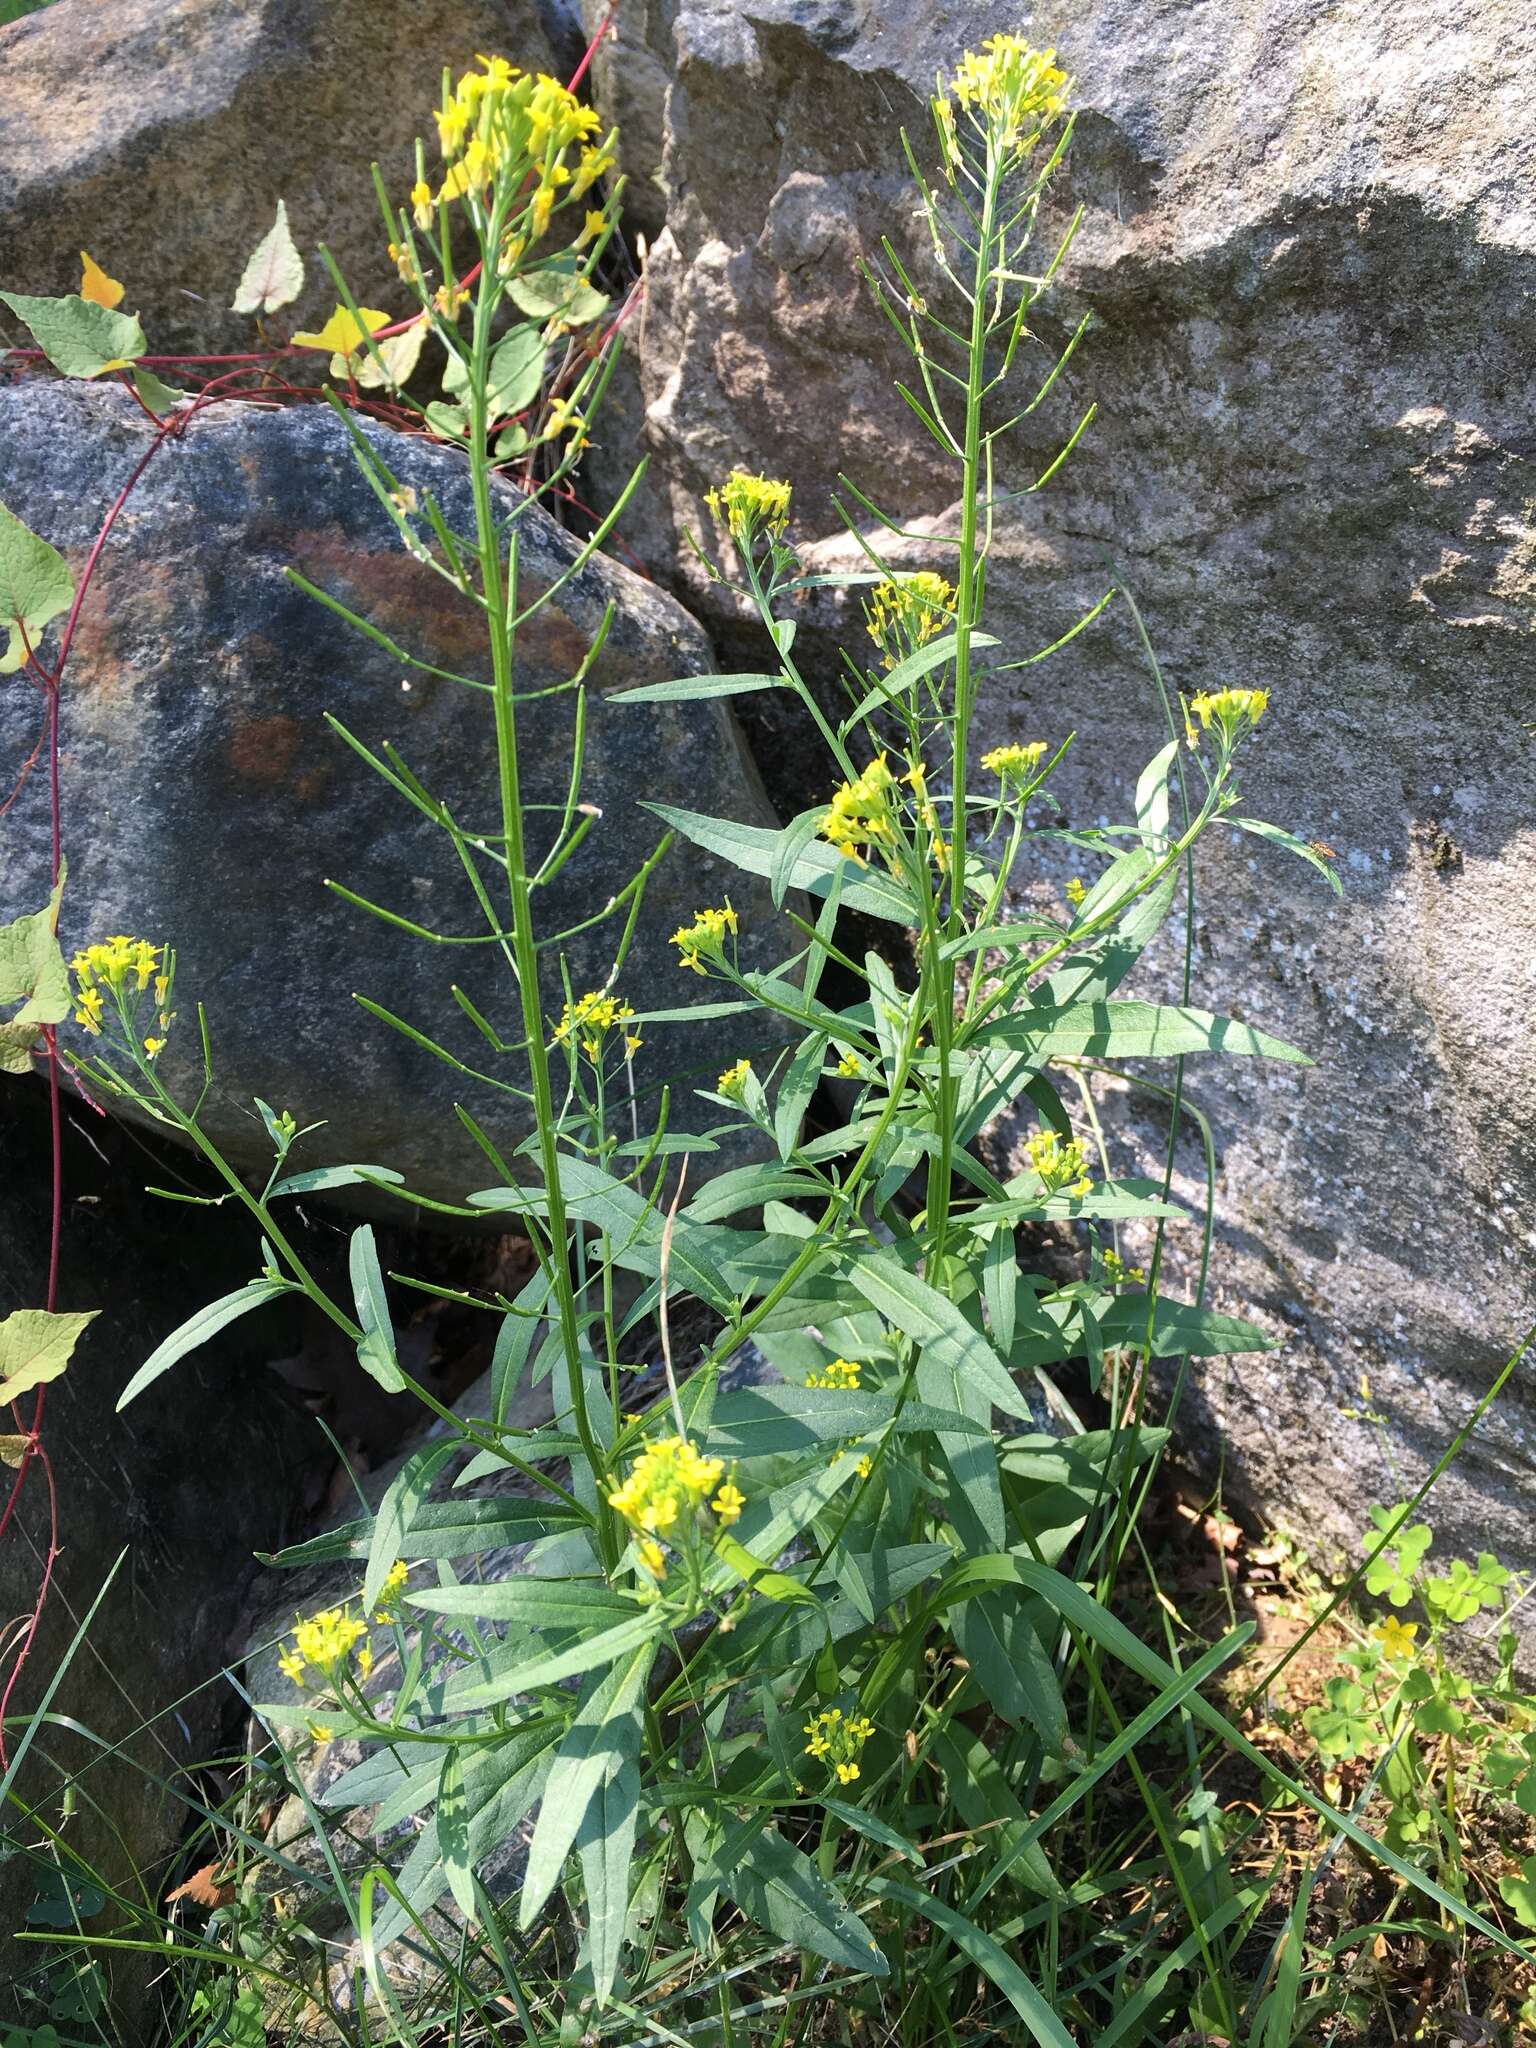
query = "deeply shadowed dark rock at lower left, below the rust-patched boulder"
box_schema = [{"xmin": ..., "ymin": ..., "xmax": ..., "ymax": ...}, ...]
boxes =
[{"xmin": 0, "ymin": 1077, "xmax": 322, "ymax": 2042}]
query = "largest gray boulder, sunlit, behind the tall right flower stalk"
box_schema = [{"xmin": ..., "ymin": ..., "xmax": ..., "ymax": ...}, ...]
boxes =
[{"xmin": 577, "ymin": 0, "xmax": 1536, "ymax": 1567}]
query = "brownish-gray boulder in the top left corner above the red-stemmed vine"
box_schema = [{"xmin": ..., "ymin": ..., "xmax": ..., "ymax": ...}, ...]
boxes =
[{"xmin": 0, "ymin": 0, "xmax": 567, "ymax": 362}]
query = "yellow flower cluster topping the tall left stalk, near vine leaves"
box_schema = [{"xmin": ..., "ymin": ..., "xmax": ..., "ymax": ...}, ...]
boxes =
[{"xmin": 428, "ymin": 57, "xmax": 614, "ymax": 240}]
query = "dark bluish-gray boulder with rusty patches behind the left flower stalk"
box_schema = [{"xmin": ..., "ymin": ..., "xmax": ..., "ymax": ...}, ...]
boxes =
[{"xmin": 0, "ymin": 381, "xmax": 786, "ymax": 1198}]
